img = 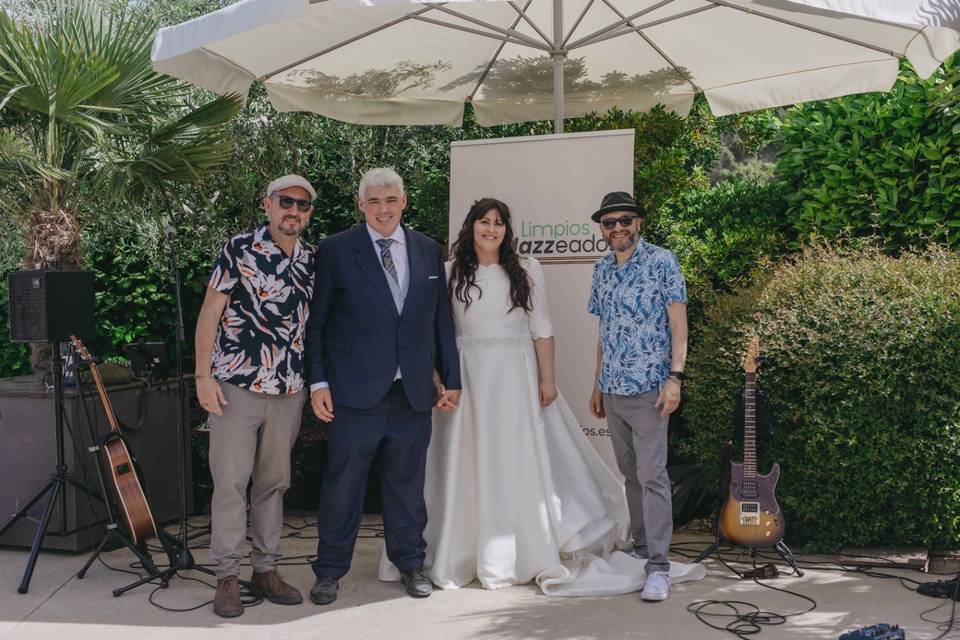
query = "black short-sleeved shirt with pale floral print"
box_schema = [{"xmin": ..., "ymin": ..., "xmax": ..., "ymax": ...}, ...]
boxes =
[{"xmin": 208, "ymin": 225, "xmax": 314, "ymax": 395}]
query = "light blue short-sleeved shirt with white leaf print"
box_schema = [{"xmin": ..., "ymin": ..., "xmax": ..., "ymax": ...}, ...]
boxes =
[{"xmin": 587, "ymin": 240, "xmax": 687, "ymax": 396}]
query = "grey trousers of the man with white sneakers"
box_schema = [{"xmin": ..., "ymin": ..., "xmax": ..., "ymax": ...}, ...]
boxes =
[{"xmin": 603, "ymin": 391, "xmax": 673, "ymax": 573}]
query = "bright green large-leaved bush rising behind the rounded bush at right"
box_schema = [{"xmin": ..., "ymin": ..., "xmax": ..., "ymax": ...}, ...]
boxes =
[{"xmin": 777, "ymin": 62, "xmax": 960, "ymax": 249}]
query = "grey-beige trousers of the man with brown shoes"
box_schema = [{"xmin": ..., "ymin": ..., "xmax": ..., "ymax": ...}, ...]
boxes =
[{"xmin": 209, "ymin": 382, "xmax": 307, "ymax": 579}]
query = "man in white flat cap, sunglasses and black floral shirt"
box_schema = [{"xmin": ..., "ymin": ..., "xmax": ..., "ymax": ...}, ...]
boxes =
[{"xmin": 195, "ymin": 175, "xmax": 317, "ymax": 618}]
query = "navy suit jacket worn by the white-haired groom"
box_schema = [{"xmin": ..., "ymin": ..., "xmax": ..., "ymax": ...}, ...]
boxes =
[{"xmin": 306, "ymin": 224, "xmax": 460, "ymax": 411}]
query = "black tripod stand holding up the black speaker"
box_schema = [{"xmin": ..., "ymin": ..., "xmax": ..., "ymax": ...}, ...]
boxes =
[{"xmin": 0, "ymin": 341, "xmax": 102, "ymax": 593}]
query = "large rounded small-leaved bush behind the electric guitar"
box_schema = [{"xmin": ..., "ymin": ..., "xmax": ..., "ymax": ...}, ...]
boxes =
[{"xmin": 672, "ymin": 248, "xmax": 960, "ymax": 548}]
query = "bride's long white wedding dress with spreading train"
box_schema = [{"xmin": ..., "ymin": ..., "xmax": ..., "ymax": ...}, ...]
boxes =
[{"xmin": 380, "ymin": 258, "xmax": 703, "ymax": 596}]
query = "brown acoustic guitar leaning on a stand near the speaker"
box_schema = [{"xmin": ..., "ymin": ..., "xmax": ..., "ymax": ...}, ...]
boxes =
[{"xmin": 70, "ymin": 335, "xmax": 157, "ymax": 544}]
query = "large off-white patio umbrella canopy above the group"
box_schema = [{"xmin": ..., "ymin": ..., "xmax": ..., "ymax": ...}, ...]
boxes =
[{"xmin": 153, "ymin": 0, "xmax": 960, "ymax": 132}]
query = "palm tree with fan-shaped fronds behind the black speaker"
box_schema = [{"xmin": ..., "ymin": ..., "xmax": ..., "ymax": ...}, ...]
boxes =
[{"xmin": 0, "ymin": 0, "xmax": 242, "ymax": 269}]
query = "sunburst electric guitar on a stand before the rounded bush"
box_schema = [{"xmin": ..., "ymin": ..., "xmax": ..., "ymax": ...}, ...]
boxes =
[{"xmin": 720, "ymin": 337, "xmax": 784, "ymax": 547}]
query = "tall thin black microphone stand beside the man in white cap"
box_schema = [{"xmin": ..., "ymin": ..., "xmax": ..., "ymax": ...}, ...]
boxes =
[{"xmin": 113, "ymin": 227, "xmax": 216, "ymax": 596}]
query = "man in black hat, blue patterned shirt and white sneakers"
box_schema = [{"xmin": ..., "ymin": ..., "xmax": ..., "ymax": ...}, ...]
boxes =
[{"xmin": 588, "ymin": 191, "xmax": 687, "ymax": 601}]
